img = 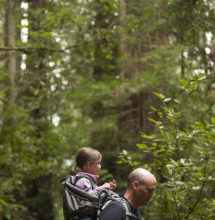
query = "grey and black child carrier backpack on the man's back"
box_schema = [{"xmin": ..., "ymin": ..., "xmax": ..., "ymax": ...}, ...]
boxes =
[{"xmin": 61, "ymin": 176, "xmax": 141, "ymax": 220}]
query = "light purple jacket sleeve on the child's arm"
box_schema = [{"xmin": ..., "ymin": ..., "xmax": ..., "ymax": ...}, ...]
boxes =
[{"xmin": 75, "ymin": 178, "xmax": 102, "ymax": 196}]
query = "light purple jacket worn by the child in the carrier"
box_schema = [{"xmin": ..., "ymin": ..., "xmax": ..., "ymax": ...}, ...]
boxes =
[{"xmin": 71, "ymin": 172, "xmax": 102, "ymax": 196}]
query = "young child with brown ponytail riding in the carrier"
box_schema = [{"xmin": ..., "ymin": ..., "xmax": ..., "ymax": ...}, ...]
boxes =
[{"xmin": 71, "ymin": 147, "xmax": 116, "ymax": 220}]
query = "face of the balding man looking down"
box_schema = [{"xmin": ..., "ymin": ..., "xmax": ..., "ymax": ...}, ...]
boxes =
[{"xmin": 136, "ymin": 178, "xmax": 156, "ymax": 206}]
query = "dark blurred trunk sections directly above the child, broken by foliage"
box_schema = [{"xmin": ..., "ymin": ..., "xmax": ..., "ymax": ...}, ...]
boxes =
[{"xmin": 89, "ymin": 0, "xmax": 118, "ymax": 173}]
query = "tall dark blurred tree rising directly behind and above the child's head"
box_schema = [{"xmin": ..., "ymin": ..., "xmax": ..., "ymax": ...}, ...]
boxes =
[{"xmin": 81, "ymin": 0, "xmax": 119, "ymax": 173}]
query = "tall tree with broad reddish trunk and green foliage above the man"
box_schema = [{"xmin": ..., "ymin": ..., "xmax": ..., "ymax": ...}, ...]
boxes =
[{"xmin": 118, "ymin": 0, "xmax": 168, "ymax": 158}]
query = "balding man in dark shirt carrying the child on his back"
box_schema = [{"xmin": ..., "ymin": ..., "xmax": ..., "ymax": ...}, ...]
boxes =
[{"xmin": 99, "ymin": 168, "xmax": 156, "ymax": 220}]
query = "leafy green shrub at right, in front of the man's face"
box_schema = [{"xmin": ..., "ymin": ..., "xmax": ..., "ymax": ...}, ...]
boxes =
[{"xmin": 121, "ymin": 93, "xmax": 215, "ymax": 219}]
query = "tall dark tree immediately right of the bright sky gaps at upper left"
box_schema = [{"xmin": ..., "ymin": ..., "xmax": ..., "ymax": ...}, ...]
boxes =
[{"xmin": 19, "ymin": 0, "xmax": 54, "ymax": 220}]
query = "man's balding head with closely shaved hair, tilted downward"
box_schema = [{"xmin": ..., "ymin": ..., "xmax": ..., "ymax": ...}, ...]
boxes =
[{"xmin": 125, "ymin": 168, "xmax": 156, "ymax": 208}]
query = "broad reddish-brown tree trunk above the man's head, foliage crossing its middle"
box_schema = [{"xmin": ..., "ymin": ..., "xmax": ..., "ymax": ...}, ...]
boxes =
[{"xmin": 118, "ymin": 0, "xmax": 167, "ymax": 153}]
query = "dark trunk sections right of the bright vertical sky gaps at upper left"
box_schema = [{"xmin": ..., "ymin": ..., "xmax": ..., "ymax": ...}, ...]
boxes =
[{"xmin": 23, "ymin": 0, "xmax": 54, "ymax": 220}]
